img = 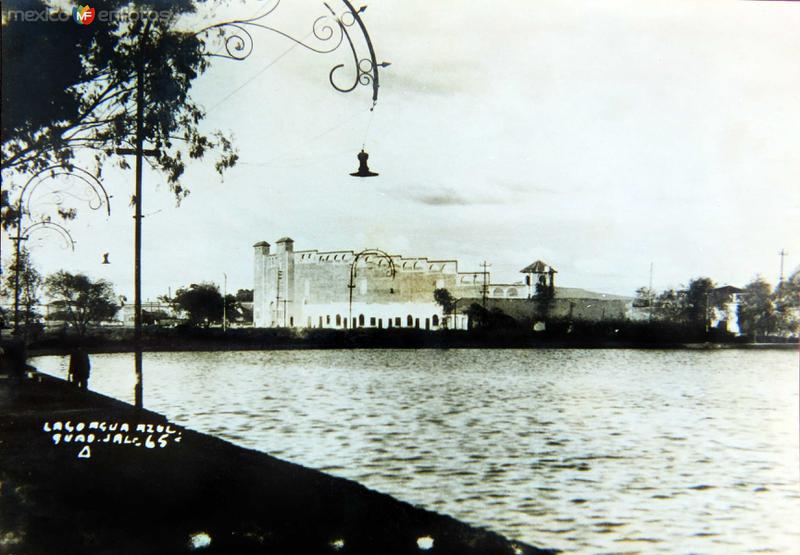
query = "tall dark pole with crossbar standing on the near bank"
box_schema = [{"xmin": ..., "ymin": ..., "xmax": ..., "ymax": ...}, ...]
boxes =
[{"xmin": 116, "ymin": 21, "xmax": 158, "ymax": 409}]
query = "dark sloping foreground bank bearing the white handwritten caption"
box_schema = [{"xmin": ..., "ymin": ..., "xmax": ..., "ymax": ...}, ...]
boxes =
[{"xmin": 0, "ymin": 374, "xmax": 548, "ymax": 555}]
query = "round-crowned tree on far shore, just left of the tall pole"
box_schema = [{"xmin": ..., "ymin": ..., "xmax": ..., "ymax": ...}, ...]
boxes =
[{"xmin": 44, "ymin": 270, "xmax": 119, "ymax": 336}]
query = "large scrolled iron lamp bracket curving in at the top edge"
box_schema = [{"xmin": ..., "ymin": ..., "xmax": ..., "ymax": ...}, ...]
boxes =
[{"xmin": 196, "ymin": 0, "xmax": 389, "ymax": 108}]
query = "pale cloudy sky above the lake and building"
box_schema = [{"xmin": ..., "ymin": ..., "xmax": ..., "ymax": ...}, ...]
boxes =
[{"xmin": 3, "ymin": 0, "xmax": 800, "ymax": 298}]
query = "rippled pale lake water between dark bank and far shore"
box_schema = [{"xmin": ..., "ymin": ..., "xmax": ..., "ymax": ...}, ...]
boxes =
[{"xmin": 34, "ymin": 349, "xmax": 800, "ymax": 553}]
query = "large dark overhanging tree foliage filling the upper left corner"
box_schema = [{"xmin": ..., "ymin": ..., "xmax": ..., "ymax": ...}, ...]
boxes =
[{"xmin": 0, "ymin": 0, "xmax": 237, "ymax": 199}]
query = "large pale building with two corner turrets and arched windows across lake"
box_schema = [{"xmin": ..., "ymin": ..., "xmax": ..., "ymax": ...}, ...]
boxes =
[{"xmin": 253, "ymin": 237, "xmax": 628, "ymax": 329}]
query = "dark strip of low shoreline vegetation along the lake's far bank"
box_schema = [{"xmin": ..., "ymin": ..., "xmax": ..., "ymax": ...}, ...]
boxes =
[{"xmin": 21, "ymin": 322, "xmax": 797, "ymax": 354}]
